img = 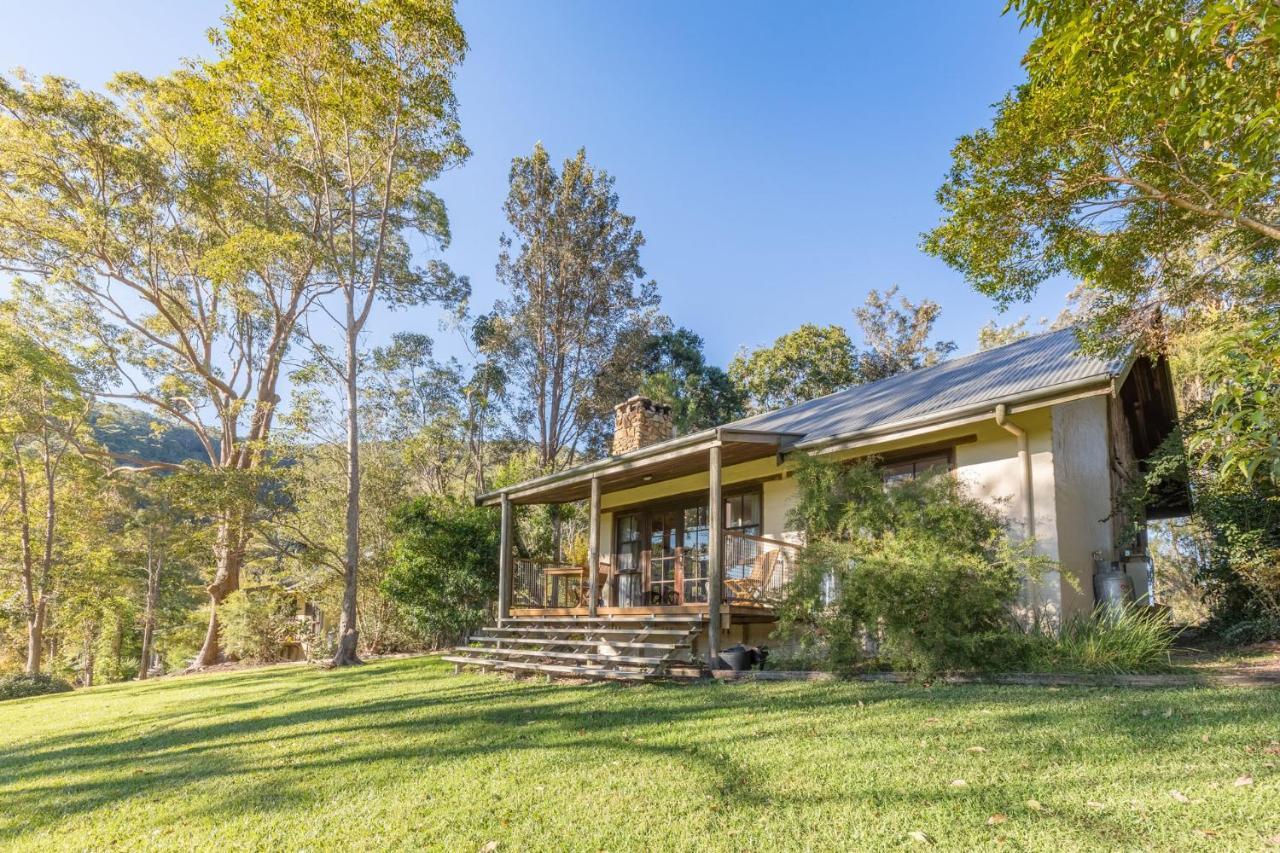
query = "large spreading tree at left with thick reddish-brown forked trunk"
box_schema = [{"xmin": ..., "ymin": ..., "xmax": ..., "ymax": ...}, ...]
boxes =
[{"xmin": 0, "ymin": 70, "xmax": 323, "ymax": 666}]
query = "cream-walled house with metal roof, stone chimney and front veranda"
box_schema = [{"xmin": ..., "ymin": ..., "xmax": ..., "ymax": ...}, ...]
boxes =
[{"xmin": 448, "ymin": 329, "xmax": 1185, "ymax": 679}]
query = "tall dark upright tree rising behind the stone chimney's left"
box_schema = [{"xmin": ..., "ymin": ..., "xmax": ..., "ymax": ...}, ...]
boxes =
[{"xmin": 476, "ymin": 143, "xmax": 658, "ymax": 471}]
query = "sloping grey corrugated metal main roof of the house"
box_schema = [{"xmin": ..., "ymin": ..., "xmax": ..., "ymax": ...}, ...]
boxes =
[{"xmin": 726, "ymin": 328, "xmax": 1125, "ymax": 444}]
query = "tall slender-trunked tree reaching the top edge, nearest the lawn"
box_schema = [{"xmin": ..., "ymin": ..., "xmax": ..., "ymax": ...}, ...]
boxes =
[{"xmin": 209, "ymin": 0, "xmax": 468, "ymax": 665}]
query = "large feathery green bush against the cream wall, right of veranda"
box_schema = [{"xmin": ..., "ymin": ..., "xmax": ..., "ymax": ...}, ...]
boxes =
[{"xmin": 780, "ymin": 450, "xmax": 1048, "ymax": 674}]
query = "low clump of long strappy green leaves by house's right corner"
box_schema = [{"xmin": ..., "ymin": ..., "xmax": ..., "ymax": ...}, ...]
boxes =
[{"xmin": 1032, "ymin": 605, "xmax": 1178, "ymax": 674}]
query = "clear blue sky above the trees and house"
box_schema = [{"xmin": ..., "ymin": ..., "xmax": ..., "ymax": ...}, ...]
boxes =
[{"xmin": 0, "ymin": 0, "xmax": 1069, "ymax": 365}]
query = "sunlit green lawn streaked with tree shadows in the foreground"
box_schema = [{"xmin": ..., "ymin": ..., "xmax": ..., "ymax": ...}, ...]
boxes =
[{"xmin": 0, "ymin": 658, "xmax": 1280, "ymax": 852}]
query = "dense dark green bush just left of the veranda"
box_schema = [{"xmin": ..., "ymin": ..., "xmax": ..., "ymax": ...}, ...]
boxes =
[{"xmin": 383, "ymin": 498, "xmax": 498, "ymax": 644}]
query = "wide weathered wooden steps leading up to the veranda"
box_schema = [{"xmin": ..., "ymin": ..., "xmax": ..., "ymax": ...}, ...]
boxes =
[{"xmin": 444, "ymin": 616, "xmax": 704, "ymax": 681}]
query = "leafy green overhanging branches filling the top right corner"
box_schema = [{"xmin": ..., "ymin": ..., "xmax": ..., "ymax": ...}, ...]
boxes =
[{"xmin": 924, "ymin": 0, "xmax": 1280, "ymax": 343}]
